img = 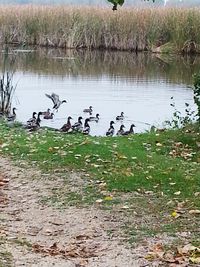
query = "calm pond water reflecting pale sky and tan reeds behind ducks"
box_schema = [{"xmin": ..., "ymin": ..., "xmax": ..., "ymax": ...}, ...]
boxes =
[{"xmin": 1, "ymin": 48, "xmax": 200, "ymax": 135}]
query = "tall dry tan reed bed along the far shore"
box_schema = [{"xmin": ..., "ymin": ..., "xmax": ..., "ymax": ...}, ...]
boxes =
[{"xmin": 0, "ymin": 5, "xmax": 200, "ymax": 51}]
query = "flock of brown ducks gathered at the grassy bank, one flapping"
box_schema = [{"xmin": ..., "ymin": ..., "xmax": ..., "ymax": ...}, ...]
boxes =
[{"xmin": 4, "ymin": 93, "xmax": 135, "ymax": 136}]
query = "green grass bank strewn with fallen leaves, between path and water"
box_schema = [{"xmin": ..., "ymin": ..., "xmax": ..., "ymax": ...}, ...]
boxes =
[{"xmin": 0, "ymin": 123, "xmax": 200, "ymax": 207}]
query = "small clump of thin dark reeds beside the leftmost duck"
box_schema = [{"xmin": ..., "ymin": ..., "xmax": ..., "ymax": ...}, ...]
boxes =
[{"xmin": 0, "ymin": 72, "xmax": 16, "ymax": 115}]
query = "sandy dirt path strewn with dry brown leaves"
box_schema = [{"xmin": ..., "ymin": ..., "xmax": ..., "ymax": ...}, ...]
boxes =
[{"xmin": 0, "ymin": 158, "xmax": 143, "ymax": 267}]
